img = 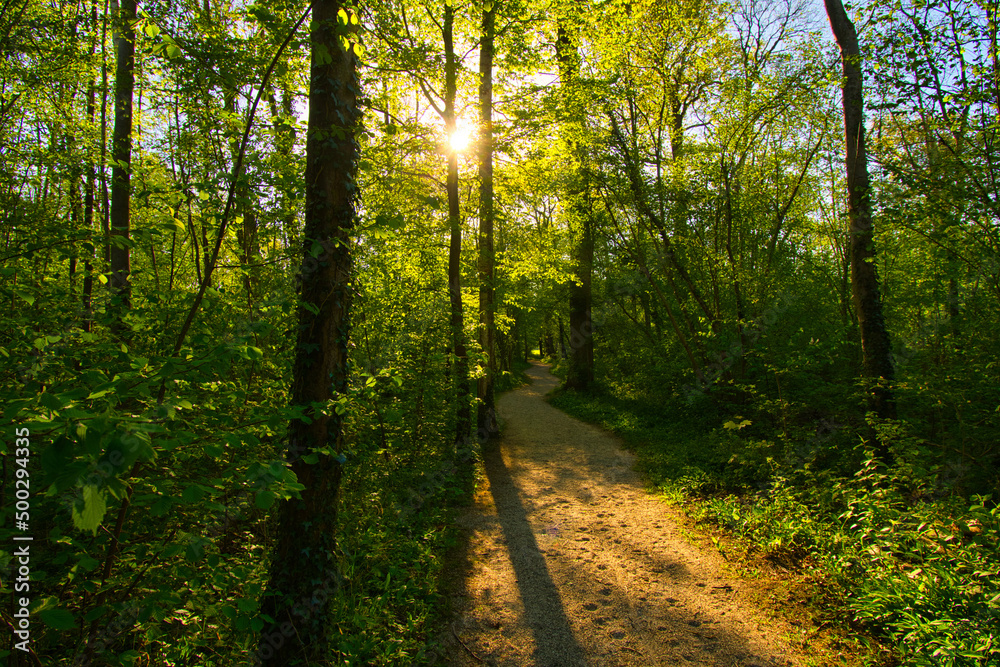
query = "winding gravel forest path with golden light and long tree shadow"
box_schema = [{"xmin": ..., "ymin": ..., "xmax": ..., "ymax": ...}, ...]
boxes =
[{"xmin": 445, "ymin": 364, "xmax": 802, "ymax": 667}]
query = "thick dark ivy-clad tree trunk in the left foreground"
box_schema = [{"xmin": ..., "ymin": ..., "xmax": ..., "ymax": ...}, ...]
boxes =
[{"xmin": 257, "ymin": 0, "xmax": 361, "ymax": 666}]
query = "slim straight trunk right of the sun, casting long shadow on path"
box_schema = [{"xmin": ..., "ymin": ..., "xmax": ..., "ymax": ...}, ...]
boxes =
[{"xmin": 476, "ymin": 3, "xmax": 497, "ymax": 439}]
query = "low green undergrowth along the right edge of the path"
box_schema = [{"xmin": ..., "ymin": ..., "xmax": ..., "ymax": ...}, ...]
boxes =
[{"xmin": 552, "ymin": 385, "xmax": 1000, "ymax": 667}]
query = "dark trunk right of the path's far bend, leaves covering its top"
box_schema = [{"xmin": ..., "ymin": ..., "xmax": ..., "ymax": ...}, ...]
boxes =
[{"xmin": 556, "ymin": 19, "xmax": 594, "ymax": 391}]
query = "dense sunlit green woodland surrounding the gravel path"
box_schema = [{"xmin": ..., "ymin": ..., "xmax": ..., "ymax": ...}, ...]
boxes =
[{"xmin": 0, "ymin": 0, "xmax": 1000, "ymax": 665}]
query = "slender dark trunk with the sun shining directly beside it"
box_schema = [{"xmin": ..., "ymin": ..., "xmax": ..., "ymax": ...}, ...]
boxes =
[{"xmin": 442, "ymin": 2, "xmax": 472, "ymax": 445}]
